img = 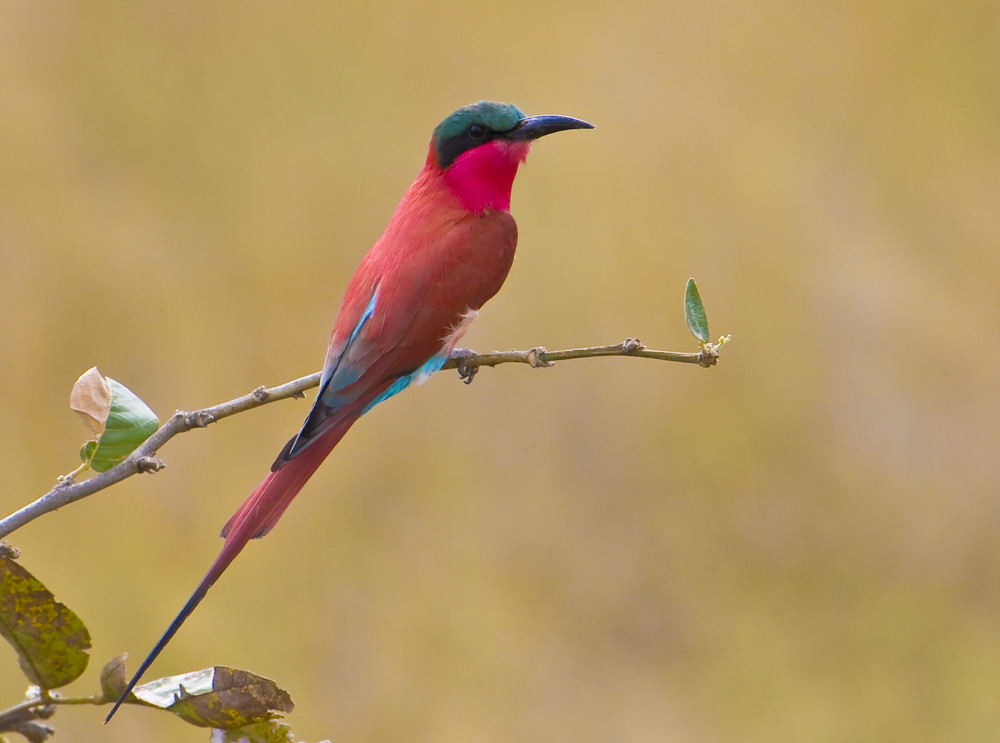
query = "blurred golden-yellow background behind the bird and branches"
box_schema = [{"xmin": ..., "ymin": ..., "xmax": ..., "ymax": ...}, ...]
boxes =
[{"xmin": 0, "ymin": 0, "xmax": 1000, "ymax": 743}]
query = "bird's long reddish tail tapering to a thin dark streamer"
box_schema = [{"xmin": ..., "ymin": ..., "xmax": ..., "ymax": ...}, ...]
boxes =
[{"xmin": 104, "ymin": 419, "xmax": 354, "ymax": 723}]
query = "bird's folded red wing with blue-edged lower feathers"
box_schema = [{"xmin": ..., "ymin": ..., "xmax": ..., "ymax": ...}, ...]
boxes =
[{"xmin": 272, "ymin": 206, "xmax": 517, "ymax": 469}]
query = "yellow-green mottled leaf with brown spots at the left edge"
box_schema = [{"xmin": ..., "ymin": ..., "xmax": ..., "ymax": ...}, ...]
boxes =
[{"xmin": 0, "ymin": 555, "xmax": 90, "ymax": 689}]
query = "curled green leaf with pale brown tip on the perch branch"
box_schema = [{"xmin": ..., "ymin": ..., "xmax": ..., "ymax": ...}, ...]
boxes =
[{"xmin": 69, "ymin": 366, "xmax": 160, "ymax": 472}]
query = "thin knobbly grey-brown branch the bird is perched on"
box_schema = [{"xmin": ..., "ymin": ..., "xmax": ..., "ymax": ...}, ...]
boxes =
[{"xmin": 0, "ymin": 338, "xmax": 718, "ymax": 537}]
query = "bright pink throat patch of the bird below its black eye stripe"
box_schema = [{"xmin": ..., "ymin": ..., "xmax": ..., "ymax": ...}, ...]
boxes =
[{"xmin": 444, "ymin": 140, "xmax": 531, "ymax": 212}]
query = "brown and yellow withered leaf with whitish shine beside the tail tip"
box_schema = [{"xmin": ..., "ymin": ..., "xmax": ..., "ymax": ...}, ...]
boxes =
[{"xmin": 134, "ymin": 666, "xmax": 295, "ymax": 730}]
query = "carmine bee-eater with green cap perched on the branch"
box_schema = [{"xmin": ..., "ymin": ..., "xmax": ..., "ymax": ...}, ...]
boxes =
[{"xmin": 105, "ymin": 101, "xmax": 593, "ymax": 722}]
